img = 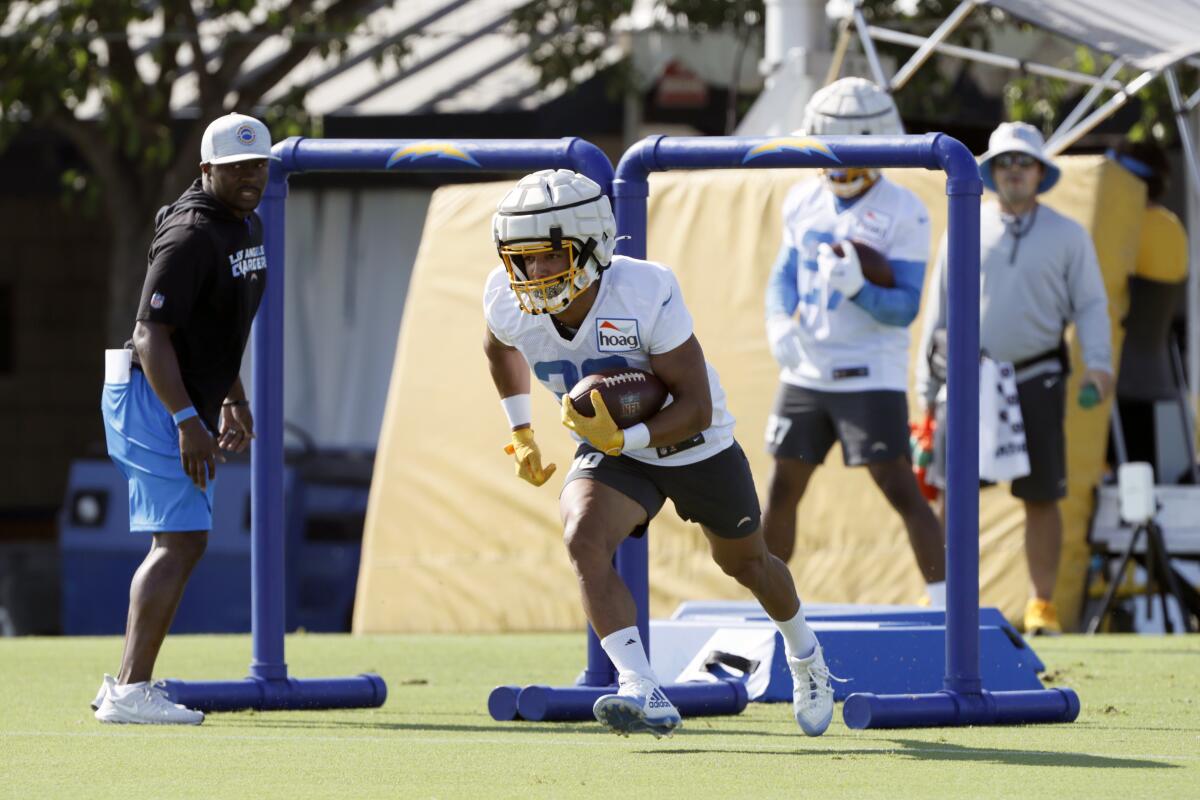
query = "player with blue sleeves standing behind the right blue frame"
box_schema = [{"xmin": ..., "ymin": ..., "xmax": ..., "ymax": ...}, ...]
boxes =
[{"xmin": 763, "ymin": 78, "xmax": 946, "ymax": 606}]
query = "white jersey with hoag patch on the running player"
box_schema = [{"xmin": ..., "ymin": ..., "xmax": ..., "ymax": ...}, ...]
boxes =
[{"xmin": 484, "ymin": 255, "xmax": 733, "ymax": 467}]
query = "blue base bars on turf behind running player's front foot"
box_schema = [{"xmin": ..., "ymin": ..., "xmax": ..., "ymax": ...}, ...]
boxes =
[{"xmin": 487, "ymin": 680, "xmax": 749, "ymax": 722}]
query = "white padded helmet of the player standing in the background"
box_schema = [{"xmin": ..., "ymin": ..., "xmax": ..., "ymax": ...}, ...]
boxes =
[{"xmin": 802, "ymin": 78, "xmax": 904, "ymax": 199}]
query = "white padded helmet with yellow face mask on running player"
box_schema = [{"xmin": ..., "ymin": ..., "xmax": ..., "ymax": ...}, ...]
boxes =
[{"xmin": 492, "ymin": 169, "xmax": 617, "ymax": 314}]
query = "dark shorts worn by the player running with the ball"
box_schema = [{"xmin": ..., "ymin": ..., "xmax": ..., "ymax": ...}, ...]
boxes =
[{"xmin": 563, "ymin": 441, "xmax": 761, "ymax": 539}]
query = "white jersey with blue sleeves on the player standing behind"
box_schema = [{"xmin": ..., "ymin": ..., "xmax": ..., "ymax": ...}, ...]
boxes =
[{"xmin": 767, "ymin": 178, "xmax": 929, "ymax": 391}]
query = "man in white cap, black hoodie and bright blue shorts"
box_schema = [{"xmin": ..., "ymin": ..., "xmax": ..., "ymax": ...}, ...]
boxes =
[{"xmin": 92, "ymin": 114, "xmax": 271, "ymax": 724}]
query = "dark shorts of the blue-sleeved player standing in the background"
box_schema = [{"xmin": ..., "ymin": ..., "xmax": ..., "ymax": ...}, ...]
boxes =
[{"xmin": 767, "ymin": 384, "xmax": 910, "ymax": 467}]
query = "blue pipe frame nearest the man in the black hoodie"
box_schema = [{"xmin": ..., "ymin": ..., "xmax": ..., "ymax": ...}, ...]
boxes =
[{"xmin": 159, "ymin": 137, "xmax": 613, "ymax": 711}]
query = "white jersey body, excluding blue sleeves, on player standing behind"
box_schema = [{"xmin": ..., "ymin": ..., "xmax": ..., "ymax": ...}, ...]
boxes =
[{"xmin": 780, "ymin": 178, "xmax": 929, "ymax": 391}]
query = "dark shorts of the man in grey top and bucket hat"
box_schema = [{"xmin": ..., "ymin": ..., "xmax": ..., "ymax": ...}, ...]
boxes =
[{"xmin": 930, "ymin": 372, "xmax": 1067, "ymax": 503}]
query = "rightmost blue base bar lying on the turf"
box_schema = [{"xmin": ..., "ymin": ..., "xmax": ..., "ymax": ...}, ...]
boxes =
[{"xmin": 842, "ymin": 688, "xmax": 1079, "ymax": 729}]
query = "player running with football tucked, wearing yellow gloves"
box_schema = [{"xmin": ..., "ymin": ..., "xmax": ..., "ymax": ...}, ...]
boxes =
[{"xmin": 484, "ymin": 169, "xmax": 833, "ymax": 736}]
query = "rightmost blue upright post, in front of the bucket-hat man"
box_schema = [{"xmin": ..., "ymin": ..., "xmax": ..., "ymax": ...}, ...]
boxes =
[{"xmin": 941, "ymin": 134, "xmax": 983, "ymax": 694}]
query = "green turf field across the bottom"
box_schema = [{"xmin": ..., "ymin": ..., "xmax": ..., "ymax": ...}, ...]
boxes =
[{"xmin": 0, "ymin": 634, "xmax": 1200, "ymax": 800}]
